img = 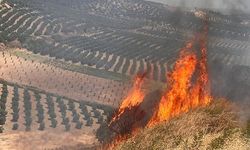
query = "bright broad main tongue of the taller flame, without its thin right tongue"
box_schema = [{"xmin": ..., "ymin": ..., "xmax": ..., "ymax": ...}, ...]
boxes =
[{"xmin": 148, "ymin": 42, "xmax": 197, "ymax": 126}]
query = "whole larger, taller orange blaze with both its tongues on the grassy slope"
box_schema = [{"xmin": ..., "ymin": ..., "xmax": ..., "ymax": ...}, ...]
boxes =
[{"xmin": 148, "ymin": 23, "xmax": 211, "ymax": 126}]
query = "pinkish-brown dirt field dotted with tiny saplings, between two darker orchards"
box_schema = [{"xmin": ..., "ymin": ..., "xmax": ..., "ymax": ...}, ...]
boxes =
[{"xmin": 0, "ymin": 51, "xmax": 131, "ymax": 106}]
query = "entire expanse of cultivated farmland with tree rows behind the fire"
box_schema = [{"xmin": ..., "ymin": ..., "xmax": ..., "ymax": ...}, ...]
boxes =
[{"xmin": 0, "ymin": 0, "xmax": 250, "ymax": 149}]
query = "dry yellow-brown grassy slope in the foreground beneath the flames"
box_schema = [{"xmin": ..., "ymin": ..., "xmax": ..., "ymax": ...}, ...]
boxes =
[{"xmin": 117, "ymin": 101, "xmax": 250, "ymax": 150}]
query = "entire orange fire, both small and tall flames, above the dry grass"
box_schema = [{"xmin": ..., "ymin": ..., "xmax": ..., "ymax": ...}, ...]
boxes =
[{"xmin": 109, "ymin": 21, "xmax": 211, "ymax": 146}]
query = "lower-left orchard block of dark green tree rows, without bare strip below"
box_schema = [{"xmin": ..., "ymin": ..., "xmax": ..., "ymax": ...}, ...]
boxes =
[{"xmin": 0, "ymin": 80, "xmax": 112, "ymax": 133}]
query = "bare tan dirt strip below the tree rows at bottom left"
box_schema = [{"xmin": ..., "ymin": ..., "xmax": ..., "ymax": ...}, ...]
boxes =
[{"xmin": 0, "ymin": 131, "xmax": 97, "ymax": 150}]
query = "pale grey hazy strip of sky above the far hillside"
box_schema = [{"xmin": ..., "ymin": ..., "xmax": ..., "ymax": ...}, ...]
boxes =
[{"xmin": 150, "ymin": 0, "xmax": 250, "ymax": 13}]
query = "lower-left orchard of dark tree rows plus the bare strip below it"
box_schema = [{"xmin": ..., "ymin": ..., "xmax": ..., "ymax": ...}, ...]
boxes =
[{"xmin": 0, "ymin": 80, "xmax": 112, "ymax": 149}]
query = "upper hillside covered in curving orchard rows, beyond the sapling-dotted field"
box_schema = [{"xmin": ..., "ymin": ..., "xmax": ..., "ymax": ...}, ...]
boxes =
[{"xmin": 0, "ymin": 0, "xmax": 250, "ymax": 81}]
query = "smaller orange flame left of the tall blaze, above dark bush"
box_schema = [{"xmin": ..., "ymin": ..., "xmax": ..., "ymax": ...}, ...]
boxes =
[{"xmin": 110, "ymin": 73, "xmax": 146, "ymax": 124}]
